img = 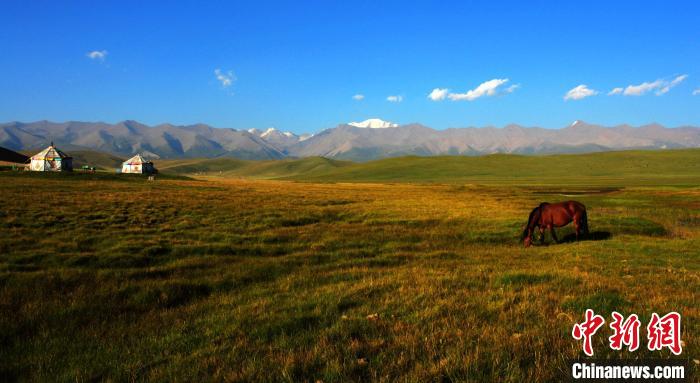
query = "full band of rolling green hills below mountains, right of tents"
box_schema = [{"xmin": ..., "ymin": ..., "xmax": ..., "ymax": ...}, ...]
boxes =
[{"xmin": 157, "ymin": 149, "xmax": 700, "ymax": 185}]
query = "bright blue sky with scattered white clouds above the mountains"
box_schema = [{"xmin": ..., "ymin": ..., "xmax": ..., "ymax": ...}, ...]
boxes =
[{"xmin": 0, "ymin": 1, "xmax": 700, "ymax": 133}]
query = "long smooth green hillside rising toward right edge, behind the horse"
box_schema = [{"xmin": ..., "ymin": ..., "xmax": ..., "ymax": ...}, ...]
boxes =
[{"xmin": 284, "ymin": 149, "xmax": 700, "ymax": 185}]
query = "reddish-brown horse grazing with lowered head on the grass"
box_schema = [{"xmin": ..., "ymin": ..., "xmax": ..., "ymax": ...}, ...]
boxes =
[{"xmin": 521, "ymin": 201, "xmax": 588, "ymax": 247}]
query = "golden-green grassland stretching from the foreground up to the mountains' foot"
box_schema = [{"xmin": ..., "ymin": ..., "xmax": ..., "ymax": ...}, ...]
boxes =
[{"xmin": 0, "ymin": 151, "xmax": 700, "ymax": 382}]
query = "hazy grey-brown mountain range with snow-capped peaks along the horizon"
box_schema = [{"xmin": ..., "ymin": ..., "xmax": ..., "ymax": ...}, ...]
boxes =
[{"xmin": 0, "ymin": 119, "xmax": 700, "ymax": 161}]
